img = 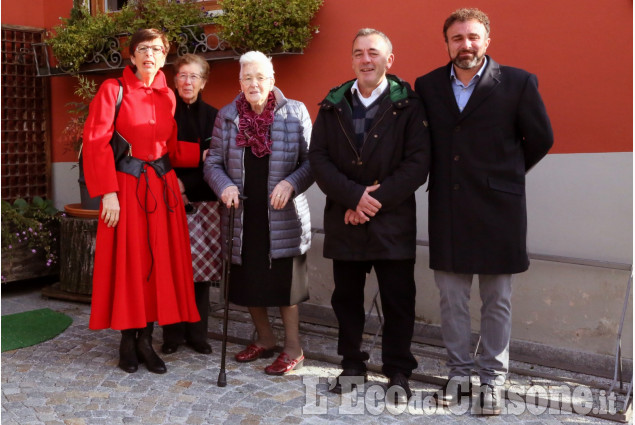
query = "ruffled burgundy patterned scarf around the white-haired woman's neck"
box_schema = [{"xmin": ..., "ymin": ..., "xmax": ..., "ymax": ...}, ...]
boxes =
[{"xmin": 236, "ymin": 92, "xmax": 276, "ymax": 158}]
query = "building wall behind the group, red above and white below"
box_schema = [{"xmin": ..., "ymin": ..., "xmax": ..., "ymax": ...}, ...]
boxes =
[{"xmin": 2, "ymin": 0, "xmax": 633, "ymax": 358}]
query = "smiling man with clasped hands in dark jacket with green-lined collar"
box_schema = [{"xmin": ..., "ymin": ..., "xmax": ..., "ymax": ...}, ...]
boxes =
[{"xmin": 309, "ymin": 28, "xmax": 430, "ymax": 402}]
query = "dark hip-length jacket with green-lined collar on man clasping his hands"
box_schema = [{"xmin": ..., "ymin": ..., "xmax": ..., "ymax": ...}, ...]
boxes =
[{"xmin": 309, "ymin": 75, "xmax": 430, "ymax": 261}]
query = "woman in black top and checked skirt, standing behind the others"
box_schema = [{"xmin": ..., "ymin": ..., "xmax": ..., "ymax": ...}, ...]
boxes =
[{"xmin": 161, "ymin": 53, "xmax": 218, "ymax": 354}]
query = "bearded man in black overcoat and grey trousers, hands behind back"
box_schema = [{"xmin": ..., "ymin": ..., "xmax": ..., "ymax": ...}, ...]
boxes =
[{"xmin": 415, "ymin": 9, "xmax": 553, "ymax": 414}]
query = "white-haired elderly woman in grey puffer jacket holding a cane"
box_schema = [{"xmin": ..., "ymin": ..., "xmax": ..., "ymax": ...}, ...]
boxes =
[{"xmin": 204, "ymin": 52, "xmax": 313, "ymax": 375}]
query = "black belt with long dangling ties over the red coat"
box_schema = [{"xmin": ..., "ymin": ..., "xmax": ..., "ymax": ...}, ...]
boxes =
[{"xmin": 115, "ymin": 155, "xmax": 178, "ymax": 280}]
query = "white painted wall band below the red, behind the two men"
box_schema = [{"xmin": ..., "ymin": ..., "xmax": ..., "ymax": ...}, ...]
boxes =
[{"xmin": 307, "ymin": 153, "xmax": 633, "ymax": 264}]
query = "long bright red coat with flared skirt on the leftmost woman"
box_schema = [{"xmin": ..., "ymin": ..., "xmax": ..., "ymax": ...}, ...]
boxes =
[{"xmin": 83, "ymin": 67, "xmax": 200, "ymax": 329}]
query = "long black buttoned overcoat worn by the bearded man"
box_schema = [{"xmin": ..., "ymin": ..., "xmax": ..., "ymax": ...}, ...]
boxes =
[{"xmin": 415, "ymin": 57, "xmax": 553, "ymax": 274}]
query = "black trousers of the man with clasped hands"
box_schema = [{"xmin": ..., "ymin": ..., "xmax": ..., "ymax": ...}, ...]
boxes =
[{"xmin": 331, "ymin": 259, "xmax": 417, "ymax": 377}]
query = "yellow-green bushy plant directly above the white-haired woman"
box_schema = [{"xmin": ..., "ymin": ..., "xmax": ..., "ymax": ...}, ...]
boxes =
[{"xmin": 215, "ymin": 0, "xmax": 323, "ymax": 53}]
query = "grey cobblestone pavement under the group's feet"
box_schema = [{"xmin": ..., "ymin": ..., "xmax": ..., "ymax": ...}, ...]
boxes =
[{"xmin": 1, "ymin": 289, "xmax": 623, "ymax": 425}]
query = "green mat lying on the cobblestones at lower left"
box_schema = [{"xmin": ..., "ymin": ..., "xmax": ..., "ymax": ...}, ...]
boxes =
[{"xmin": 0, "ymin": 308, "xmax": 73, "ymax": 353}]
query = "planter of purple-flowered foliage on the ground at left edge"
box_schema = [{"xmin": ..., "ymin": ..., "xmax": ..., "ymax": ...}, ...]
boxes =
[{"xmin": 1, "ymin": 196, "xmax": 60, "ymax": 283}]
